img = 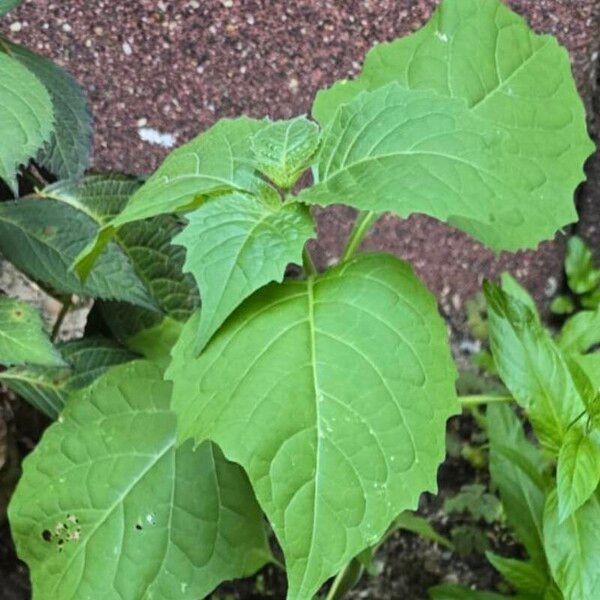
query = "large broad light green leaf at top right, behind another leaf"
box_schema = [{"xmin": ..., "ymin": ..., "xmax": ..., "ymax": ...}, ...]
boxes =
[{"xmin": 313, "ymin": 0, "xmax": 593, "ymax": 249}]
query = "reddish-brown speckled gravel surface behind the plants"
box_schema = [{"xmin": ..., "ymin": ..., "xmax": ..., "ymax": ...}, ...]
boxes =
[{"xmin": 6, "ymin": 0, "xmax": 600, "ymax": 325}]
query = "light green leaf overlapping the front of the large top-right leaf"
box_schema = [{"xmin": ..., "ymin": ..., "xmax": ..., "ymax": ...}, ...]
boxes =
[{"xmin": 299, "ymin": 83, "xmax": 581, "ymax": 250}]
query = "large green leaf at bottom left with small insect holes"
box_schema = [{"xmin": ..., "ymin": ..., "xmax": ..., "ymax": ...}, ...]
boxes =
[{"xmin": 9, "ymin": 362, "xmax": 269, "ymax": 600}]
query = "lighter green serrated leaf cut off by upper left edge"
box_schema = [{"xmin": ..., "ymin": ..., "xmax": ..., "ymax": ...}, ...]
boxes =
[{"xmin": 0, "ymin": 52, "xmax": 54, "ymax": 195}]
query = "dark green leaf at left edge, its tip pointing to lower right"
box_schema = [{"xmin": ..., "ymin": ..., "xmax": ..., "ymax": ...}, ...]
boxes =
[{"xmin": 0, "ymin": 198, "xmax": 156, "ymax": 310}]
